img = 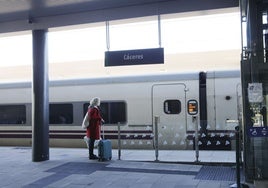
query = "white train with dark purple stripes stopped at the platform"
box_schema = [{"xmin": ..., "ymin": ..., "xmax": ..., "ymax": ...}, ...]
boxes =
[{"xmin": 0, "ymin": 70, "xmax": 241, "ymax": 150}]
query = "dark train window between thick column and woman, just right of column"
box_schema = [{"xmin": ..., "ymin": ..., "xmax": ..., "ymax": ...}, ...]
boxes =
[{"xmin": 49, "ymin": 104, "xmax": 73, "ymax": 124}]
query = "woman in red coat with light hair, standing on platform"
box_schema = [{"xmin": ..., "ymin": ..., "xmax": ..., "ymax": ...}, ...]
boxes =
[{"xmin": 86, "ymin": 97, "xmax": 102, "ymax": 159}]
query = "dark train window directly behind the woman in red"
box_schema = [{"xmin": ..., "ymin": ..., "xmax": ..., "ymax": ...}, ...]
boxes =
[{"xmin": 84, "ymin": 101, "xmax": 126, "ymax": 124}]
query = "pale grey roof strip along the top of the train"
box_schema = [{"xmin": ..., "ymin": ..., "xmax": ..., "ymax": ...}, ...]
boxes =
[{"xmin": 0, "ymin": 70, "xmax": 240, "ymax": 89}]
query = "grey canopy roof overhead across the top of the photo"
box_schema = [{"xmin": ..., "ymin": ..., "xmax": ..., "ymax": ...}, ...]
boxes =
[{"xmin": 0, "ymin": 0, "xmax": 239, "ymax": 33}]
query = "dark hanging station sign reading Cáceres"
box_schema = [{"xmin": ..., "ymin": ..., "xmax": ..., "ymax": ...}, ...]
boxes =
[{"xmin": 105, "ymin": 48, "xmax": 164, "ymax": 67}]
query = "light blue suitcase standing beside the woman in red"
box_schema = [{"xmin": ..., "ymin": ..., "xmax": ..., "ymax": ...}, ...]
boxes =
[{"xmin": 98, "ymin": 140, "xmax": 112, "ymax": 161}]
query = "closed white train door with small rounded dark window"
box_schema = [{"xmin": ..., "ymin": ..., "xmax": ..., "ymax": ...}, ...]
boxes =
[{"xmin": 152, "ymin": 84, "xmax": 187, "ymax": 149}]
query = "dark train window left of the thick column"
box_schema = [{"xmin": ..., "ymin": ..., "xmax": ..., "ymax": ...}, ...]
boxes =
[{"xmin": 0, "ymin": 105, "xmax": 26, "ymax": 124}]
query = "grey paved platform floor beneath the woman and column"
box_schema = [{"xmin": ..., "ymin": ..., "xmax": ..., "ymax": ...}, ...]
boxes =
[{"xmin": 0, "ymin": 147, "xmax": 253, "ymax": 188}]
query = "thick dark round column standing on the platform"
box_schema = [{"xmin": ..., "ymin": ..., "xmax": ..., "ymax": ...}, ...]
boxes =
[{"xmin": 32, "ymin": 30, "xmax": 49, "ymax": 162}]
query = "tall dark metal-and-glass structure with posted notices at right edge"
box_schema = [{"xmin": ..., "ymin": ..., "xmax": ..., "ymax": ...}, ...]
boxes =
[{"xmin": 240, "ymin": 0, "xmax": 268, "ymax": 184}]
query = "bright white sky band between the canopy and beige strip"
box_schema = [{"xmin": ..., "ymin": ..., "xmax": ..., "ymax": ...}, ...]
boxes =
[{"xmin": 0, "ymin": 12, "xmax": 241, "ymax": 67}]
